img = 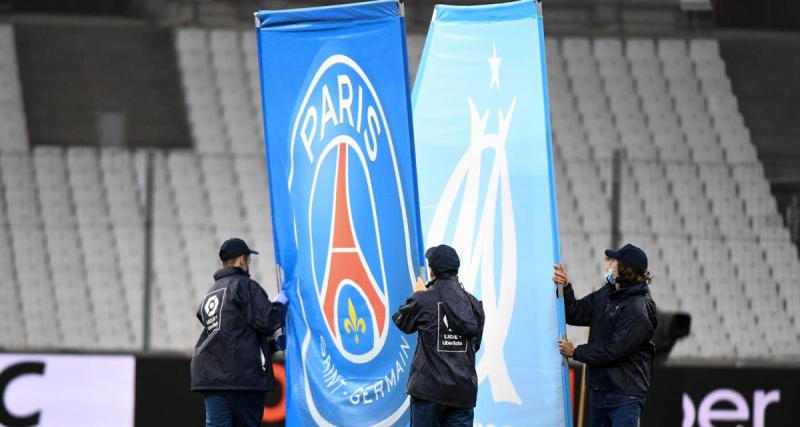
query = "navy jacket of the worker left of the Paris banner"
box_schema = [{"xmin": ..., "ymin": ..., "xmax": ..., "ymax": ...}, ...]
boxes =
[{"xmin": 191, "ymin": 267, "xmax": 286, "ymax": 391}]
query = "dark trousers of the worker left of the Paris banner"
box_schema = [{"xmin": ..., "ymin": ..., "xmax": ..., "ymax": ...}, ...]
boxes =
[{"xmin": 204, "ymin": 390, "xmax": 266, "ymax": 427}]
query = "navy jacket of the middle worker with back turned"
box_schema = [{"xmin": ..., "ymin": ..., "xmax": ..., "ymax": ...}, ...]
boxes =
[{"xmin": 392, "ymin": 277, "xmax": 484, "ymax": 408}]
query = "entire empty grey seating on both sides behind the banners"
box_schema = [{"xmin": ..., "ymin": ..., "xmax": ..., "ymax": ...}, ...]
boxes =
[{"xmin": 0, "ymin": 27, "xmax": 800, "ymax": 359}]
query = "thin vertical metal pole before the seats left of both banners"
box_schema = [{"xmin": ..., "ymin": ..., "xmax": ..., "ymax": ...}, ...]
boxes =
[{"xmin": 142, "ymin": 149, "xmax": 155, "ymax": 352}]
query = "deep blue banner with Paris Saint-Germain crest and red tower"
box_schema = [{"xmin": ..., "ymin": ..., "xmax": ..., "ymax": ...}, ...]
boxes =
[{"xmin": 256, "ymin": 1, "xmax": 423, "ymax": 426}]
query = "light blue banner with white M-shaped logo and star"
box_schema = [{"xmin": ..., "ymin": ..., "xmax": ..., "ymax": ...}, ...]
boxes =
[{"xmin": 412, "ymin": 0, "xmax": 572, "ymax": 427}]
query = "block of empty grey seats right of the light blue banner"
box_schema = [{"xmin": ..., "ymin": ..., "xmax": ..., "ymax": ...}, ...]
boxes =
[{"xmin": 547, "ymin": 37, "xmax": 800, "ymax": 358}]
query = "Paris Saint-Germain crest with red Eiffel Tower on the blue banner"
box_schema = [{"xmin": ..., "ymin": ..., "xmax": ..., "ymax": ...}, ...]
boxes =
[{"xmin": 288, "ymin": 55, "xmax": 415, "ymax": 425}]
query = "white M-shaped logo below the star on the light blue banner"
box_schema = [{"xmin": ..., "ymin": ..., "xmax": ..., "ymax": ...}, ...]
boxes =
[{"xmin": 427, "ymin": 98, "xmax": 522, "ymax": 404}]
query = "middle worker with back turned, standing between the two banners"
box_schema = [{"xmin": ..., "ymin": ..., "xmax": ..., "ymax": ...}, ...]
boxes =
[{"xmin": 392, "ymin": 245, "xmax": 484, "ymax": 427}]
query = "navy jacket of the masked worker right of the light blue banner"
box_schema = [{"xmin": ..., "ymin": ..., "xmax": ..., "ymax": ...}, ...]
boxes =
[{"xmin": 564, "ymin": 283, "xmax": 657, "ymax": 398}]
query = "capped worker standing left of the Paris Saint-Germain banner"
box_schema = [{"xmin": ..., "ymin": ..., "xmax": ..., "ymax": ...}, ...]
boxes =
[{"xmin": 191, "ymin": 238, "xmax": 287, "ymax": 427}]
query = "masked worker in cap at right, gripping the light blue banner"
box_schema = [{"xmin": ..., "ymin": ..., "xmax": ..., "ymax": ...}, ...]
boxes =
[{"xmin": 553, "ymin": 244, "xmax": 657, "ymax": 427}]
